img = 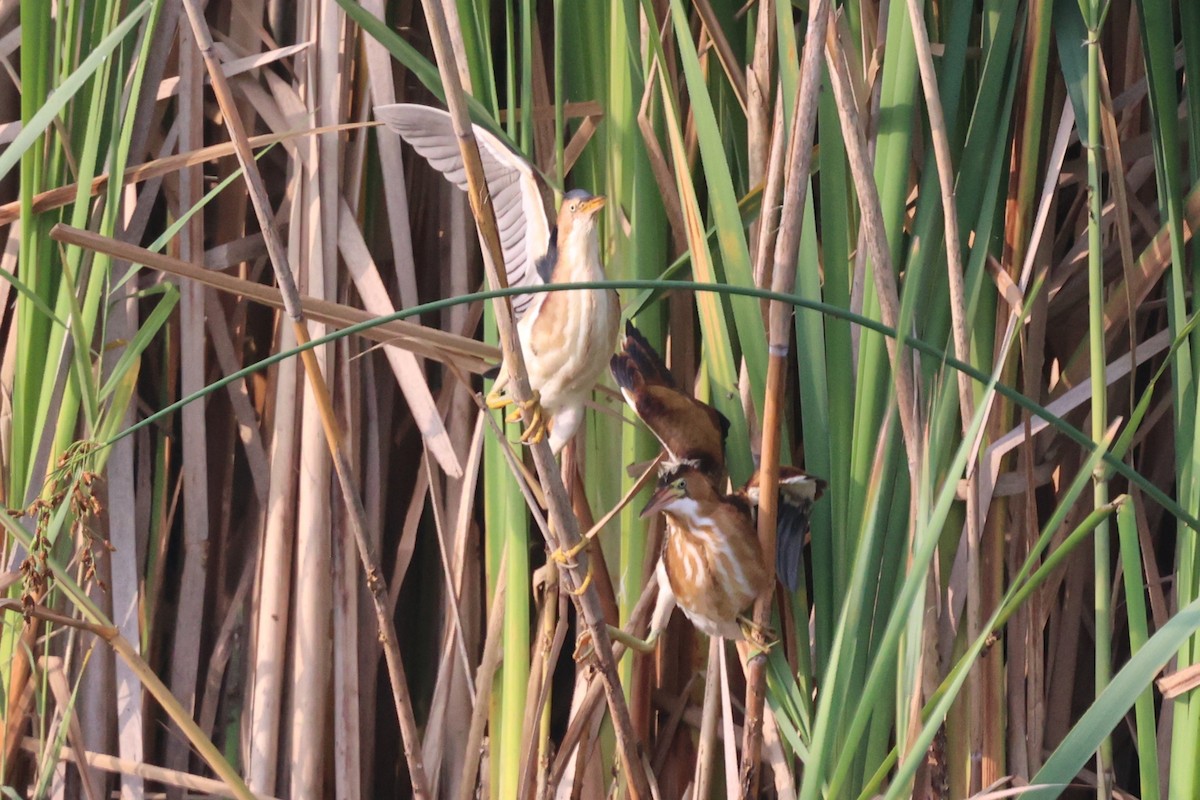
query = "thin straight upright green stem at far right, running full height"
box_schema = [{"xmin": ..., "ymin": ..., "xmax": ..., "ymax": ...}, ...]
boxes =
[{"xmin": 1085, "ymin": 0, "xmax": 1112, "ymax": 800}]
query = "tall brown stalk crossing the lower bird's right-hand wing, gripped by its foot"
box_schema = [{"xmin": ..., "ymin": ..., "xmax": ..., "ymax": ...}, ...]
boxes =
[{"xmin": 739, "ymin": 0, "xmax": 829, "ymax": 798}]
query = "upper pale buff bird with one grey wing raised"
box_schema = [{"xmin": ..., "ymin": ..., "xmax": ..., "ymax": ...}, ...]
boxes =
[{"xmin": 376, "ymin": 103, "xmax": 620, "ymax": 453}]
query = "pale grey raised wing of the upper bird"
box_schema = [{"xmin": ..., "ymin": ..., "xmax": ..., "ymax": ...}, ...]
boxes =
[{"xmin": 374, "ymin": 103, "xmax": 551, "ymax": 319}]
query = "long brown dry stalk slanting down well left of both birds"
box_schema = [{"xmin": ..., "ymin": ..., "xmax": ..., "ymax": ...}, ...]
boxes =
[{"xmin": 175, "ymin": 0, "xmax": 432, "ymax": 798}]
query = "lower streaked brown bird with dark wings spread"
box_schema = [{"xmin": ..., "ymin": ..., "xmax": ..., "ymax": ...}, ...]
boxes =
[{"xmin": 612, "ymin": 325, "xmax": 824, "ymax": 650}]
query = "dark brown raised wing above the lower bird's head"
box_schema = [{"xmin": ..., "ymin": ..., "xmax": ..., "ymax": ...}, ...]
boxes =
[{"xmin": 610, "ymin": 321, "xmax": 730, "ymax": 491}]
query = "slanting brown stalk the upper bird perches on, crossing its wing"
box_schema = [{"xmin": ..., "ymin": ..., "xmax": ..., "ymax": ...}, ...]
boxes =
[{"xmin": 421, "ymin": 0, "xmax": 650, "ymax": 800}]
